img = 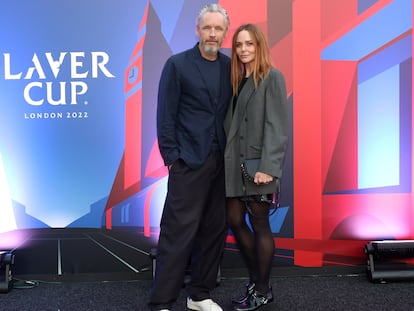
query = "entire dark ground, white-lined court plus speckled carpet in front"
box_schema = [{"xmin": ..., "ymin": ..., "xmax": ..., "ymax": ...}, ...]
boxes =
[{"xmin": 0, "ymin": 229, "xmax": 414, "ymax": 311}]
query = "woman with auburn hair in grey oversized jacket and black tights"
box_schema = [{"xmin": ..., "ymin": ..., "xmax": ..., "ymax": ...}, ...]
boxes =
[{"xmin": 224, "ymin": 24, "xmax": 288, "ymax": 311}]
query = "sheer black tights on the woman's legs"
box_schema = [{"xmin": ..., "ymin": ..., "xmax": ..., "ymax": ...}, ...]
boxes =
[{"xmin": 226, "ymin": 198, "xmax": 275, "ymax": 293}]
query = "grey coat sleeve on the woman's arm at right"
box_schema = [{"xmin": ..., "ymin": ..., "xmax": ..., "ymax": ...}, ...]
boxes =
[{"xmin": 259, "ymin": 69, "xmax": 289, "ymax": 178}]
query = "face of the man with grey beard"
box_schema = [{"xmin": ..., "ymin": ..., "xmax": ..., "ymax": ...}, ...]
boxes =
[{"xmin": 196, "ymin": 12, "xmax": 227, "ymax": 58}]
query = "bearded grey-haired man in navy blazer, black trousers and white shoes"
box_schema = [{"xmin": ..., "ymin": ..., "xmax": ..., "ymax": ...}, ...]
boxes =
[{"xmin": 149, "ymin": 4, "xmax": 231, "ymax": 311}]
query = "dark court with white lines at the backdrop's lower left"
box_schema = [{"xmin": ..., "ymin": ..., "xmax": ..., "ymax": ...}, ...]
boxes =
[{"xmin": 0, "ymin": 228, "xmax": 252, "ymax": 281}]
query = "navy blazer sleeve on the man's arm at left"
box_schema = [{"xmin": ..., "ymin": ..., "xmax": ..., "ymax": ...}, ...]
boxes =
[{"xmin": 157, "ymin": 58, "xmax": 181, "ymax": 165}]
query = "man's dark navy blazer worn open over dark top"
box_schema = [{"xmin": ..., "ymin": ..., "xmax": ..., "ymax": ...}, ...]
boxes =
[{"xmin": 157, "ymin": 44, "xmax": 231, "ymax": 169}]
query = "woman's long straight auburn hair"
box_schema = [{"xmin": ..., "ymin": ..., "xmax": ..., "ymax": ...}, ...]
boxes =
[{"xmin": 231, "ymin": 24, "xmax": 272, "ymax": 95}]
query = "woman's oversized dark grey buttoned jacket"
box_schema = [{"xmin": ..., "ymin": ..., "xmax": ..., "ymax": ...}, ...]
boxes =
[{"xmin": 224, "ymin": 69, "xmax": 289, "ymax": 197}]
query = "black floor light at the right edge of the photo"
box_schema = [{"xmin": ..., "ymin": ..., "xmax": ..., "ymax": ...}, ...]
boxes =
[{"xmin": 364, "ymin": 240, "xmax": 414, "ymax": 282}]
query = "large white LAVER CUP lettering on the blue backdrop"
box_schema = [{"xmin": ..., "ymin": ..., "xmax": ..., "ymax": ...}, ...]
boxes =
[{"xmin": 3, "ymin": 52, "xmax": 115, "ymax": 106}]
